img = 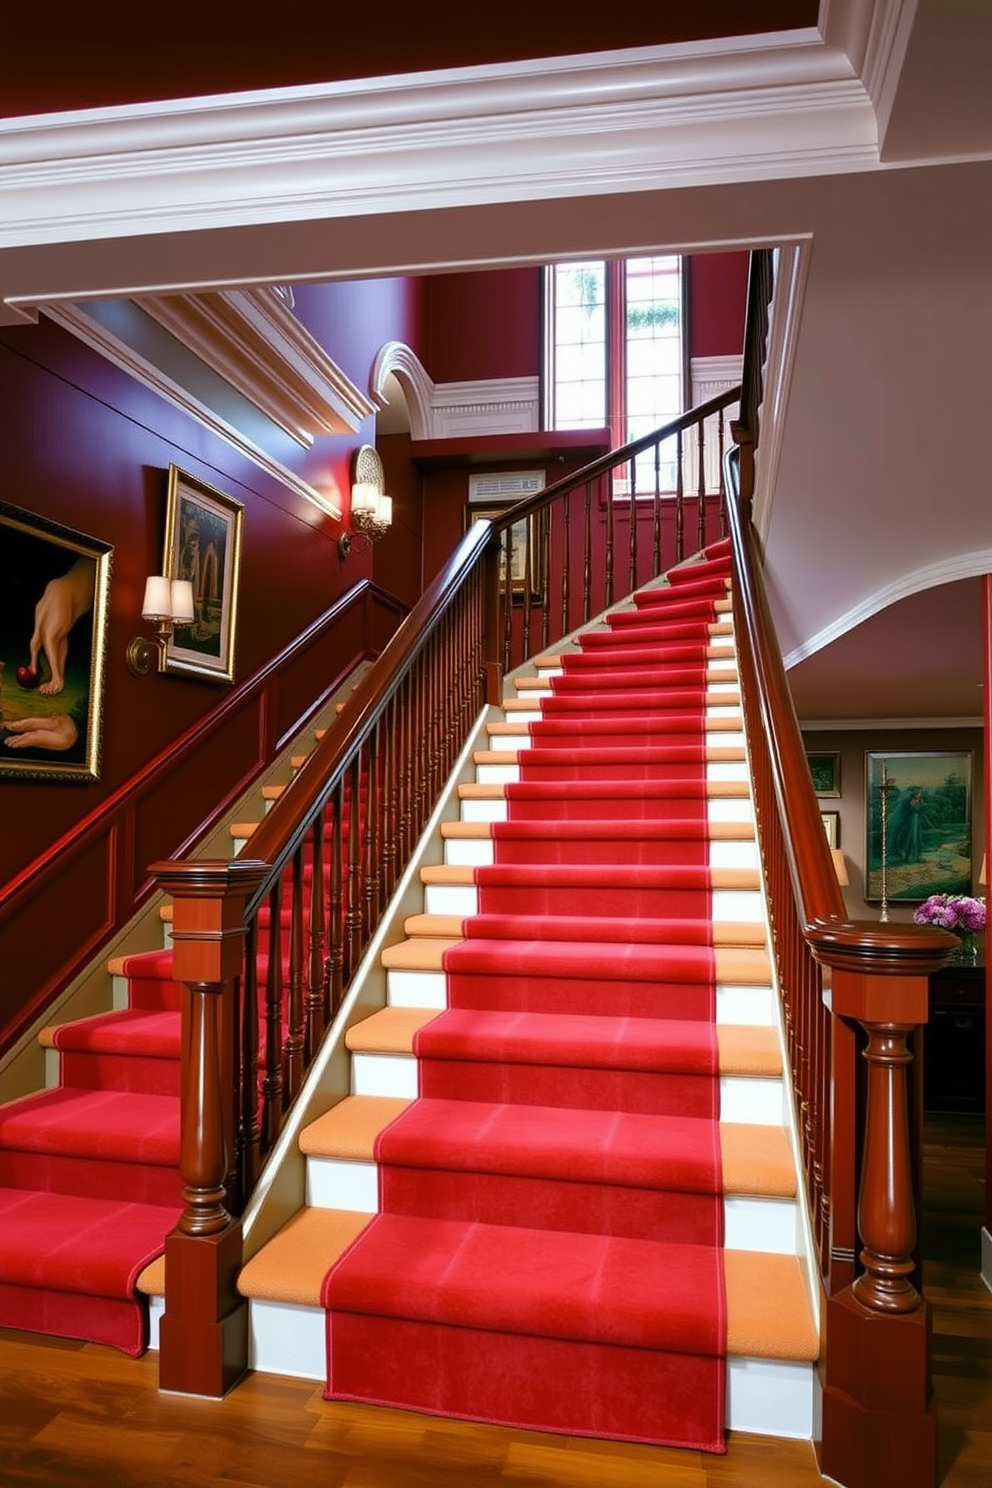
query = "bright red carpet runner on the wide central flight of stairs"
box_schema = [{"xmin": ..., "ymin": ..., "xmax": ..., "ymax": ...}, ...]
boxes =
[{"xmin": 323, "ymin": 541, "xmax": 727, "ymax": 1451}]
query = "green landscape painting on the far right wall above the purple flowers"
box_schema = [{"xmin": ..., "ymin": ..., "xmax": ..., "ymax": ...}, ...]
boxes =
[{"xmin": 864, "ymin": 750, "xmax": 971, "ymax": 903}]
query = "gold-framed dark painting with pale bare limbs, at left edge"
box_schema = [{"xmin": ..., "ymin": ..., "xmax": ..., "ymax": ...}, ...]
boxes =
[{"xmin": 0, "ymin": 501, "xmax": 113, "ymax": 781}]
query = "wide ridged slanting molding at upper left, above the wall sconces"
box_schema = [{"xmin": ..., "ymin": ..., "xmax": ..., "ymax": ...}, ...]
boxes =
[{"xmin": 135, "ymin": 287, "xmax": 375, "ymax": 448}]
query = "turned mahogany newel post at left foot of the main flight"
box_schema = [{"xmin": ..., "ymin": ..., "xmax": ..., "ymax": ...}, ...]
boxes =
[{"xmin": 150, "ymin": 860, "xmax": 265, "ymax": 1397}]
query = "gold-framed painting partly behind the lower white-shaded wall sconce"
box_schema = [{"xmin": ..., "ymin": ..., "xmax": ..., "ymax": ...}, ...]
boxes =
[{"xmin": 162, "ymin": 466, "xmax": 244, "ymax": 682}]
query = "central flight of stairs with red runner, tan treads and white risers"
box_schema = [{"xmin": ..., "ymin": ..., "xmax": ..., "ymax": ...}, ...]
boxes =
[{"xmin": 229, "ymin": 551, "xmax": 818, "ymax": 1449}]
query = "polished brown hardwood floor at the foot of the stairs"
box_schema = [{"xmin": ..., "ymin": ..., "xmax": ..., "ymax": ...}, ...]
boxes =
[{"xmin": 0, "ymin": 1116, "xmax": 992, "ymax": 1488}]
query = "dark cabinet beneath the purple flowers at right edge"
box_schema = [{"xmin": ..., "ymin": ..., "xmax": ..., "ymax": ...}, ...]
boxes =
[{"xmin": 924, "ymin": 966, "xmax": 986, "ymax": 1113}]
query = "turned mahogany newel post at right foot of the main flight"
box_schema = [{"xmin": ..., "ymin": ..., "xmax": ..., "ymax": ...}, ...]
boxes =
[{"xmin": 818, "ymin": 946, "xmax": 947, "ymax": 1488}]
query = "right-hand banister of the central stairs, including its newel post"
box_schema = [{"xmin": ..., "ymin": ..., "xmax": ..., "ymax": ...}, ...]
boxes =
[{"xmin": 727, "ymin": 244, "xmax": 955, "ymax": 1488}]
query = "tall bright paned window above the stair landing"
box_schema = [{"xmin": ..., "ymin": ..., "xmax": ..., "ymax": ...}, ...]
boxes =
[{"xmin": 544, "ymin": 254, "xmax": 686, "ymax": 493}]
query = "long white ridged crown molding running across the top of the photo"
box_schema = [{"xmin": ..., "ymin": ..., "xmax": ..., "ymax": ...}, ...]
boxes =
[{"xmin": 0, "ymin": 29, "xmax": 879, "ymax": 305}]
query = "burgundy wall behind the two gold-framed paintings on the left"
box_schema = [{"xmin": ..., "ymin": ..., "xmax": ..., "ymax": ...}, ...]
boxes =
[{"xmin": 0, "ymin": 299, "xmax": 410, "ymax": 884}]
